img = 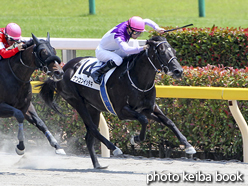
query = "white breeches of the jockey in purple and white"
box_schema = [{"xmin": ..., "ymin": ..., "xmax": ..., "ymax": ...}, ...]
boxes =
[{"xmin": 95, "ymin": 46, "xmax": 127, "ymax": 66}]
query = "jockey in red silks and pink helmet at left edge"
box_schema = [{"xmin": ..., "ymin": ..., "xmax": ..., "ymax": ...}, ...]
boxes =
[{"xmin": 0, "ymin": 23, "xmax": 24, "ymax": 60}]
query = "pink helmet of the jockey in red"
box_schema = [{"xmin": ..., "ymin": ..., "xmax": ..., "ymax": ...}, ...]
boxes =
[{"xmin": 4, "ymin": 23, "xmax": 22, "ymax": 40}]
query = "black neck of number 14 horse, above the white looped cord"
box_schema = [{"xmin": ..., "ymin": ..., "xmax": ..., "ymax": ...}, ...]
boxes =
[{"xmin": 130, "ymin": 53, "xmax": 156, "ymax": 89}]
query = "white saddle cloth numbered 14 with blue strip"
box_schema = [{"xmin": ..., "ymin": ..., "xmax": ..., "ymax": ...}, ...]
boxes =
[{"xmin": 71, "ymin": 58, "xmax": 116, "ymax": 115}]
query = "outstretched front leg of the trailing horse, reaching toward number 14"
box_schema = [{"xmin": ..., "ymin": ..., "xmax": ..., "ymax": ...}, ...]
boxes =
[{"xmin": 25, "ymin": 103, "xmax": 65, "ymax": 155}]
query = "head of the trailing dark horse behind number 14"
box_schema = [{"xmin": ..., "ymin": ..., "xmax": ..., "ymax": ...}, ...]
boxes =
[{"xmin": 32, "ymin": 33, "xmax": 64, "ymax": 81}]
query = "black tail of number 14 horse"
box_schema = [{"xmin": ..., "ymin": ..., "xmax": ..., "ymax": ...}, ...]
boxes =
[{"xmin": 37, "ymin": 79, "xmax": 63, "ymax": 115}]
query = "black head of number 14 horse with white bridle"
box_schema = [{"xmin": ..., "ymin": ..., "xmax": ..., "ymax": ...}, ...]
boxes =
[{"xmin": 147, "ymin": 36, "xmax": 183, "ymax": 78}]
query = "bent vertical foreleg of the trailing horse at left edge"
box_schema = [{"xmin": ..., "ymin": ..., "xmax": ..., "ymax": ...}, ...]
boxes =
[{"xmin": 0, "ymin": 103, "xmax": 25, "ymax": 155}]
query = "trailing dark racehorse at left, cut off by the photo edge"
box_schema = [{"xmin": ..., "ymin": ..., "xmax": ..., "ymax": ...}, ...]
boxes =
[{"xmin": 0, "ymin": 33, "xmax": 65, "ymax": 155}]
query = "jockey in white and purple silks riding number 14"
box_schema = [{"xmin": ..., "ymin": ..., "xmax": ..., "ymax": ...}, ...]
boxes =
[{"xmin": 91, "ymin": 16, "xmax": 165, "ymax": 84}]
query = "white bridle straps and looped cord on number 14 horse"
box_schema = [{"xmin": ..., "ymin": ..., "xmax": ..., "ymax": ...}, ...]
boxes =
[{"xmin": 127, "ymin": 41, "xmax": 177, "ymax": 92}]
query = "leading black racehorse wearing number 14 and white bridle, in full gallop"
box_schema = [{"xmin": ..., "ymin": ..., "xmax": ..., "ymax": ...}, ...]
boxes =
[{"xmin": 40, "ymin": 36, "xmax": 195, "ymax": 168}]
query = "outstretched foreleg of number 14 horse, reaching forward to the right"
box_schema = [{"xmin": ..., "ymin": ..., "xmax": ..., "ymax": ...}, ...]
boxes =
[{"xmin": 147, "ymin": 104, "xmax": 196, "ymax": 154}]
